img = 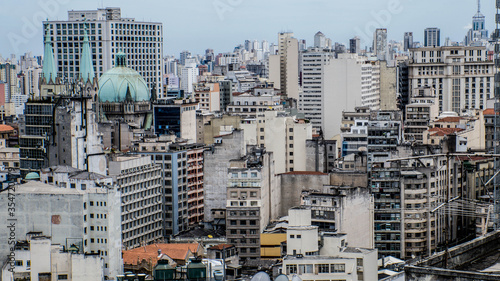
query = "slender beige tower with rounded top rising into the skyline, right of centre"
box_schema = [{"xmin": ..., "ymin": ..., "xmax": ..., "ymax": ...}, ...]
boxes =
[{"xmin": 269, "ymin": 32, "xmax": 299, "ymax": 100}]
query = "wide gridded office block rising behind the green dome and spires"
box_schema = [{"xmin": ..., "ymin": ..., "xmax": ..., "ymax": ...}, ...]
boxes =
[{"xmin": 43, "ymin": 8, "xmax": 163, "ymax": 97}]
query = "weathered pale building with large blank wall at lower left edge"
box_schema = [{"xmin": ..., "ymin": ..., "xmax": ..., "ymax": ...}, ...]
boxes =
[{"xmin": 0, "ymin": 181, "xmax": 123, "ymax": 280}]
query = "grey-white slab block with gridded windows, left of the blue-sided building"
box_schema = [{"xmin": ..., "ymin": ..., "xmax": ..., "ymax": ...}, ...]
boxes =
[{"xmin": 109, "ymin": 155, "xmax": 163, "ymax": 249}]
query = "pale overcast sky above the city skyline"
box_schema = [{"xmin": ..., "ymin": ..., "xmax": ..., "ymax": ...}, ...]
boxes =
[{"xmin": 0, "ymin": 0, "xmax": 495, "ymax": 58}]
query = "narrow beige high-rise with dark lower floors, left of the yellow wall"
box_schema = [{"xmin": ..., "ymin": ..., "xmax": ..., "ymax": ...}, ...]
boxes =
[{"xmin": 227, "ymin": 149, "xmax": 280, "ymax": 260}]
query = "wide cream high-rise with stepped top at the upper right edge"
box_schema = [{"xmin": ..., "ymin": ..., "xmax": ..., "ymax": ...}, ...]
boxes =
[{"xmin": 408, "ymin": 46, "xmax": 495, "ymax": 111}]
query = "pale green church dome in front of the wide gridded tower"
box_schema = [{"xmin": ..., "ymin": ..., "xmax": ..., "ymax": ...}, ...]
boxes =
[{"xmin": 98, "ymin": 52, "xmax": 151, "ymax": 102}]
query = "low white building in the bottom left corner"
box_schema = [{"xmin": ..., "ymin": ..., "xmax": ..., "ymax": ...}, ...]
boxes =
[{"xmin": 2, "ymin": 233, "xmax": 104, "ymax": 281}]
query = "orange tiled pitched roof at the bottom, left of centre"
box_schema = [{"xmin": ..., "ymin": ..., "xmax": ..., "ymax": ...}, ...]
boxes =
[{"xmin": 123, "ymin": 243, "xmax": 199, "ymax": 265}]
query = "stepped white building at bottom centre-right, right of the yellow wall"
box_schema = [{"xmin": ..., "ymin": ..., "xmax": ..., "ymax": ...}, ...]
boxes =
[{"xmin": 282, "ymin": 209, "xmax": 378, "ymax": 281}]
